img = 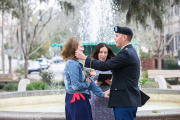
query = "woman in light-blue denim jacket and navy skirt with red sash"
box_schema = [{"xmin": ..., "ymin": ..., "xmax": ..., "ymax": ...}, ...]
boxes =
[{"xmin": 62, "ymin": 37, "xmax": 109, "ymax": 120}]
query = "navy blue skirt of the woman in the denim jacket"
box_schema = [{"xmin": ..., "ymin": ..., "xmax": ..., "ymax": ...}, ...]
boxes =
[{"xmin": 65, "ymin": 93, "xmax": 93, "ymax": 120}]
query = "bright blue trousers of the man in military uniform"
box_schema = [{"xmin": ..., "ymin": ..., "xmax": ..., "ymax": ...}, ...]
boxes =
[{"xmin": 113, "ymin": 107, "xmax": 137, "ymax": 120}]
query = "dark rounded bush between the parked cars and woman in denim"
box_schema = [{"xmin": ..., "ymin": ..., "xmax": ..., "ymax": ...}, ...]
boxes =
[{"xmin": 39, "ymin": 71, "xmax": 54, "ymax": 83}]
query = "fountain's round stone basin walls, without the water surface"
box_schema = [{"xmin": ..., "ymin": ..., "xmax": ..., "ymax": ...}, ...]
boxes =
[{"xmin": 0, "ymin": 89, "xmax": 180, "ymax": 120}]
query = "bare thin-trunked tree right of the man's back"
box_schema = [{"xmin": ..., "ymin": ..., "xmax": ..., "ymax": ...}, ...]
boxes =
[{"xmin": 138, "ymin": 28, "xmax": 179, "ymax": 70}]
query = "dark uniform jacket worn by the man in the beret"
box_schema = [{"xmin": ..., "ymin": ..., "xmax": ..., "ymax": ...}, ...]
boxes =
[{"xmin": 85, "ymin": 44, "xmax": 142, "ymax": 107}]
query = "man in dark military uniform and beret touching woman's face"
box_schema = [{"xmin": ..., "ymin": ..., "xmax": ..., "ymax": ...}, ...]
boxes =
[{"xmin": 76, "ymin": 26, "xmax": 147, "ymax": 120}]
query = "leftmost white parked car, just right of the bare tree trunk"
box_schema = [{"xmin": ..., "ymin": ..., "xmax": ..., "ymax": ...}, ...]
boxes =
[{"xmin": 28, "ymin": 61, "xmax": 41, "ymax": 74}]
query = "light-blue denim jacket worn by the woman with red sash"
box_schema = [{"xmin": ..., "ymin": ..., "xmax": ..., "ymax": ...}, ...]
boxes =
[{"xmin": 63, "ymin": 59, "xmax": 105, "ymax": 97}]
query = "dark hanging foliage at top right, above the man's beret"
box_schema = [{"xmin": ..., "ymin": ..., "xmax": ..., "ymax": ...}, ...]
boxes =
[{"xmin": 114, "ymin": 0, "xmax": 180, "ymax": 31}]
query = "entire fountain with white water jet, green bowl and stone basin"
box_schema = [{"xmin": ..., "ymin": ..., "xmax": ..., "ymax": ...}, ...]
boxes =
[{"xmin": 0, "ymin": 0, "xmax": 180, "ymax": 120}]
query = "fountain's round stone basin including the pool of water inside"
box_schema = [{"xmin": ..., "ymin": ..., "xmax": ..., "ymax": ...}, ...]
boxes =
[{"xmin": 0, "ymin": 88, "xmax": 180, "ymax": 120}]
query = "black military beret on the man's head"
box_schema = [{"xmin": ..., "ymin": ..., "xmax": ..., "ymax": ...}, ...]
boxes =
[{"xmin": 114, "ymin": 26, "xmax": 133, "ymax": 37}]
